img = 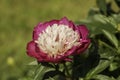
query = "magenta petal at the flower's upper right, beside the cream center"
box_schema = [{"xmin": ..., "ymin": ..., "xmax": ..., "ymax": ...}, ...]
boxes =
[{"xmin": 77, "ymin": 25, "xmax": 89, "ymax": 40}]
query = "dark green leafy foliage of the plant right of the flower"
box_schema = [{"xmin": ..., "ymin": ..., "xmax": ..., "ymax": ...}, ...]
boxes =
[{"xmin": 29, "ymin": 0, "xmax": 120, "ymax": 80}]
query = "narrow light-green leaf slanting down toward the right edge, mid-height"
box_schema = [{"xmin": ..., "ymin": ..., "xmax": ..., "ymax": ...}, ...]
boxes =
[{"xmin": 102, "ymin": 30, "xmax": 118, "ymax": 49}]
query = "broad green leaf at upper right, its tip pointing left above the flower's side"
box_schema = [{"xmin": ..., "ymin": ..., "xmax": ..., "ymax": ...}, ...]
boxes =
[{"xmin": 80, "ymin": 14, "xmax": 117, "ymax": 36}]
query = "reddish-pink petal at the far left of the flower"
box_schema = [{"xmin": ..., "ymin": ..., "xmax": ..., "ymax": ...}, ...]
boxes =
[{"xmin": 27, "ymin": 41, "xmax": 39, "ymax": 58}]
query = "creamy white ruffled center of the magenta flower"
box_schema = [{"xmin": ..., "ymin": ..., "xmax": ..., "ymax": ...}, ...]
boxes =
[{"xmin": 35, "ymin": 24, "xmax": 80, "ymax": 57}]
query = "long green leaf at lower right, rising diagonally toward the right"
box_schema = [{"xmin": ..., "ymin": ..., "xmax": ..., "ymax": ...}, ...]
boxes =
[{"xmin": 86, "ymin": 56, "xmax": 114, "ymax": 80}]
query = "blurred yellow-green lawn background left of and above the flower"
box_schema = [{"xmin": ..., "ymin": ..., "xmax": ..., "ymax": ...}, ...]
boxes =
[{"xmin": 0, "ymin": 0, "xmax": 96, "ymax": 80}]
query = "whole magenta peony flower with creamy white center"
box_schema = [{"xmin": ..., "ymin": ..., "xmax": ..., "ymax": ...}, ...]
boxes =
[{"xmin": 27, "ymin": 17, "xmax": 90, "ymax": 63}]
